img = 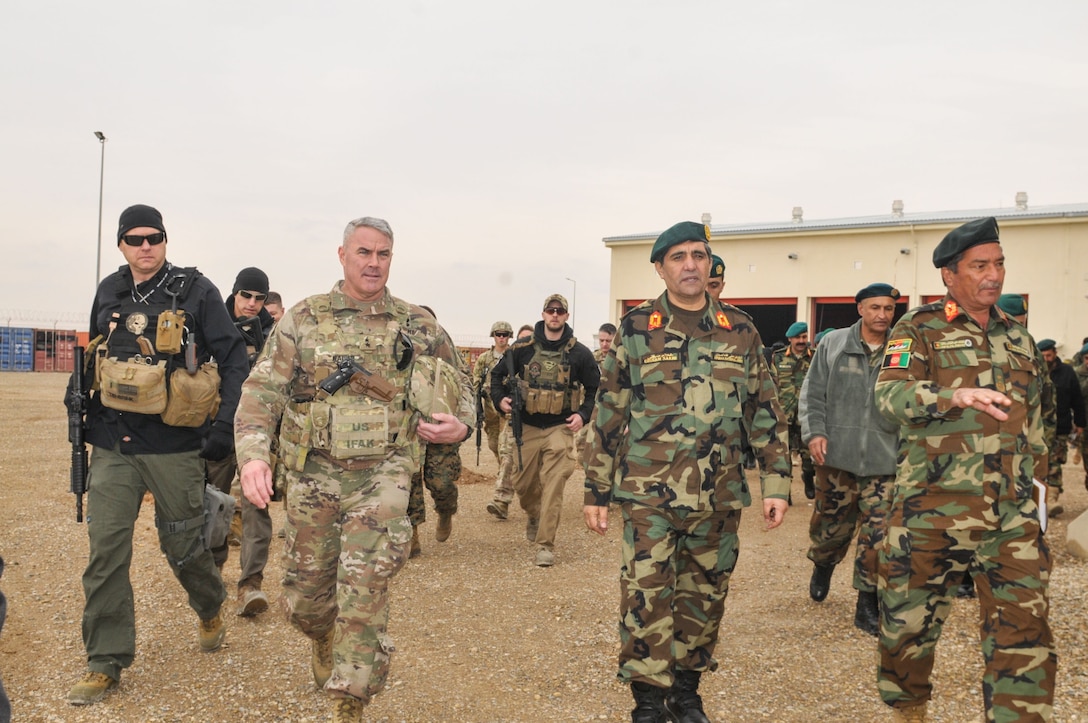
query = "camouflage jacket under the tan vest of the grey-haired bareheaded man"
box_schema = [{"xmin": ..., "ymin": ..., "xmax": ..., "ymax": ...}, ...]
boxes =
[{"xmin": 234, "ymin": 282, "xmax": 475, "ymax": 468}]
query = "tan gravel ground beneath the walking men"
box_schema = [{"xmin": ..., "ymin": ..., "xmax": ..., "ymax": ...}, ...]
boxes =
[{"xmin": 0, "ymin": 373, "xmax": 1088, "ymax": 723}]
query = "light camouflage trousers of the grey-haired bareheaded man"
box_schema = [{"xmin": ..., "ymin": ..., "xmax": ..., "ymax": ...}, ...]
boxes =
[{"xmin": 283, "ymin": 452, "xmax": 416, "ymax": 701}]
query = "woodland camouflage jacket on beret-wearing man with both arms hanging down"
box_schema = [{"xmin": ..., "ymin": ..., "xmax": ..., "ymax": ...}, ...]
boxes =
[{"xmin": 584, "ymin": 295, "xmax": 791, "ymax": 510}]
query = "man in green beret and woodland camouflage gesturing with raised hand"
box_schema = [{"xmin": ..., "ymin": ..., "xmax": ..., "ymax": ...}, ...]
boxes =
[{"xmin": 876, "ymin": 217, "xmax": 1058, "ymax": 722}]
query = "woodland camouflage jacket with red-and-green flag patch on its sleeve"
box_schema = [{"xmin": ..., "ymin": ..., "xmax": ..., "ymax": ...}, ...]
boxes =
[{"xmin": 876, "ymin": 298, "xmax": 1047, "ymax": 515}]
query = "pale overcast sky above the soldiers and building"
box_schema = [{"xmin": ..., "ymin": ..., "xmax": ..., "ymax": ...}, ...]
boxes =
[{"xmin": 0, "ymin": 0, "xmax": 1088, "ymax": 347}]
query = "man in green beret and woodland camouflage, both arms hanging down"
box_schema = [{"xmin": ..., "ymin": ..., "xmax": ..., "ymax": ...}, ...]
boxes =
[{"xmin": 583, "ymin": 222, "xmax": 790, "ymax": 723}]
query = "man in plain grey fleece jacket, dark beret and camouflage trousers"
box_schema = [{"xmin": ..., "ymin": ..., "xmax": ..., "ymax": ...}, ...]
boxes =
[{"xmin": 799, "ymin": 284, "xmax": 899, "ymax": 635}]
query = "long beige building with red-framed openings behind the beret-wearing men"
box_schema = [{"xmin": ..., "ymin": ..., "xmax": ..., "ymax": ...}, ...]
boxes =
[{"xmin": 604, "ymin": 192, "xmax": 1088, "ymax": 358}]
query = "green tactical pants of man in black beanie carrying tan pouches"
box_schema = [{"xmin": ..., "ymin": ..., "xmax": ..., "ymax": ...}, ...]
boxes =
[{"xmin": 83, "ymin": 447, "xmax": 226, "ymax": 680}]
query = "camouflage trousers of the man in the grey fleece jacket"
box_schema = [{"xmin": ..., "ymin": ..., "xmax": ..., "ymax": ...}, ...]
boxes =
[{"xmin": 808, "ymin": 465, "xmax": 895, "ymax": 593}]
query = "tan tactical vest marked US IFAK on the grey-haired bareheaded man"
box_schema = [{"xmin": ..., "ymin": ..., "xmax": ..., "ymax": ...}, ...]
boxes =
[{"xmin": 280, "ymin": 295, "xmax": 421, "ymax": 472}]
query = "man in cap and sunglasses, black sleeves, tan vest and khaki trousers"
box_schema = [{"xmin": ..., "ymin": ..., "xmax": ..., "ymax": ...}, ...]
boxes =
[{"xmin": 491, "ymin": 294, "xmax": 601, "ymax": 568}]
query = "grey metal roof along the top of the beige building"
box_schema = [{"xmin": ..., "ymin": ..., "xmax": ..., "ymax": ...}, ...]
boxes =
[{"xmin": 602, "ymin": 203, "xmax": 1088, "ymax": 244}]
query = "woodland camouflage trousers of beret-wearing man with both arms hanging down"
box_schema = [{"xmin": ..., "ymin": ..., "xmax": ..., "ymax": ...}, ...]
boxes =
[{"xmin": 617, "ymin": 502, "xmax": 741, "ymax": 687}]
